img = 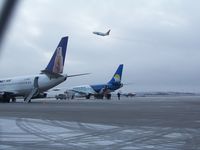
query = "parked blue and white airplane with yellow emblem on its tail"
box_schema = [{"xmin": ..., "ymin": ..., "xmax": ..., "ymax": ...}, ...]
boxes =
[{"xmin": 69, "ymin": 64, "xmax": 123, "ymax": 99}]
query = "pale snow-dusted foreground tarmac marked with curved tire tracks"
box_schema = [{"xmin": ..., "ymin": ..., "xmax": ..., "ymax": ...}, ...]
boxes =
[{"xmin": 0, "ymin": 118, "xmax": 200, "ymax": 150}]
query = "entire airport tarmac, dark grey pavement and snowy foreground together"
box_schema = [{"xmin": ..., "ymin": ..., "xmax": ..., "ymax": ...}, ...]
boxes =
[{"xmin": 0, "ymin": 98, "xmax": 200, "ymax": 150}]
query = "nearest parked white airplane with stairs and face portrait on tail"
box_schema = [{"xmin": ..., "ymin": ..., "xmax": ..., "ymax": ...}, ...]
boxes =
[{"xmin": 0, "ymin": 36, "xmax": 85, "ymax": 103}]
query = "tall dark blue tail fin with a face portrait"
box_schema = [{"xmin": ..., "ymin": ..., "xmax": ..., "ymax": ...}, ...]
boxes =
[{"xmin": 42, "ymin": 36, "xmax": 68, "ymax": 74}]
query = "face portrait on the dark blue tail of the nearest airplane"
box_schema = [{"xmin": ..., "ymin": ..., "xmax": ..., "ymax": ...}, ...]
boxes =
[{"xmin": 53, "ymin": 47, "xmax": 63, "ymax": 73}]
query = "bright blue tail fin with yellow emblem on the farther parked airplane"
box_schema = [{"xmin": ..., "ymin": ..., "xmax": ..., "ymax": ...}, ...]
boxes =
[{"xmin": 108, "ymin": 64, "xmax": 123, "ymax": 84}]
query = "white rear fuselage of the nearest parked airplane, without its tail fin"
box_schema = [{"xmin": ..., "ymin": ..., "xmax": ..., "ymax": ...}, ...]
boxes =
[{"xmin": 0, "ymin": 74, "xmax": 67, "ymax": 96}]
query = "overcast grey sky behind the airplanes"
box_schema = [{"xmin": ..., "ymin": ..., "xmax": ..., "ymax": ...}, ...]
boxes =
[{"xmin": 0, "ymin": 0, "xmax": 200, "ymax": 92}]
